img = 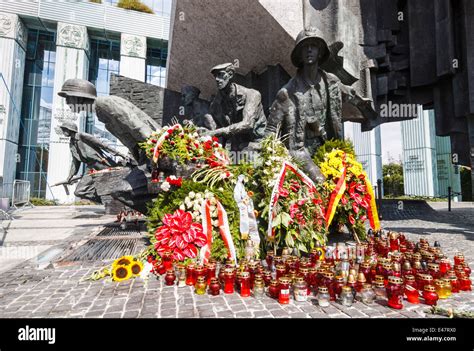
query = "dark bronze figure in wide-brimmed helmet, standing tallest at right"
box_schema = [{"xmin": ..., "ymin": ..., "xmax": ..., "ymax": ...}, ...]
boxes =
[{"xmin": 265, "ymin": 28, "xmax": 370, "ymax": 182}]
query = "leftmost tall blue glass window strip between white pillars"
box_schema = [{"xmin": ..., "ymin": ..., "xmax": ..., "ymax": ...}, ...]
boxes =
[{"xmin": 17, "ymin": 29, "xmax": 56, "ymax": 197}]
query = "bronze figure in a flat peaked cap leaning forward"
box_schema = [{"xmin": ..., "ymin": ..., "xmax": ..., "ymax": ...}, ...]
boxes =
[{"xmin": 206, "ymin": 63, "xmax": 267, "ymax": 151}]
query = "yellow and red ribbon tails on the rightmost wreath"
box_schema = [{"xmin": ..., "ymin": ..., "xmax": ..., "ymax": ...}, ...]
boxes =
[{"xmin": 326, "ymin": 153, "xmax": 380, "ymax": 230}]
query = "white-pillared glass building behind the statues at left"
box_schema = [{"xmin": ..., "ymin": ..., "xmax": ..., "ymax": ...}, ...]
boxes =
[{"xmin": 0, "ymin": 0, "xmax": 172, "ymax": 202}]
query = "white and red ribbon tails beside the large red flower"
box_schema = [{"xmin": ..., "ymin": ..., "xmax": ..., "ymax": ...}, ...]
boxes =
[{"xmin": 199, "ymin": 200, "xmax": 237, "ymax": 264}]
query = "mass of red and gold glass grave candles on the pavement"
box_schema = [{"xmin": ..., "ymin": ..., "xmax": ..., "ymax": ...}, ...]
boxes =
[{"xmin": 152, "ymin": 232, "xmax": 471, "ymax": 309}]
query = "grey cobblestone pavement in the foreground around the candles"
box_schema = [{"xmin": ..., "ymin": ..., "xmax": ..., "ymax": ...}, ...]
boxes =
[{"xmin": 0, "ymin": 204, "xmax": 474, "ymax": 318}]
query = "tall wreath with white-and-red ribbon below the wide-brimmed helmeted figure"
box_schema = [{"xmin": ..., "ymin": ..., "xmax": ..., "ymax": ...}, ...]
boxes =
[{"xmin": 253, "ymin": 137, "xmax": 326, "ymax": 252}]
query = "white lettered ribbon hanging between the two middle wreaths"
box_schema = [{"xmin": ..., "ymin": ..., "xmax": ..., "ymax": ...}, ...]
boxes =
[{"xmin": 234, "ymin": 175, "xmax": 260, "ymax": 246}]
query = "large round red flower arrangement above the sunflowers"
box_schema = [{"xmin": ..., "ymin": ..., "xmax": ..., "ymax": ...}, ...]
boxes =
[{"xmin": 155, "ymin": 210, "xmax": 207, "ymax": 261}]
